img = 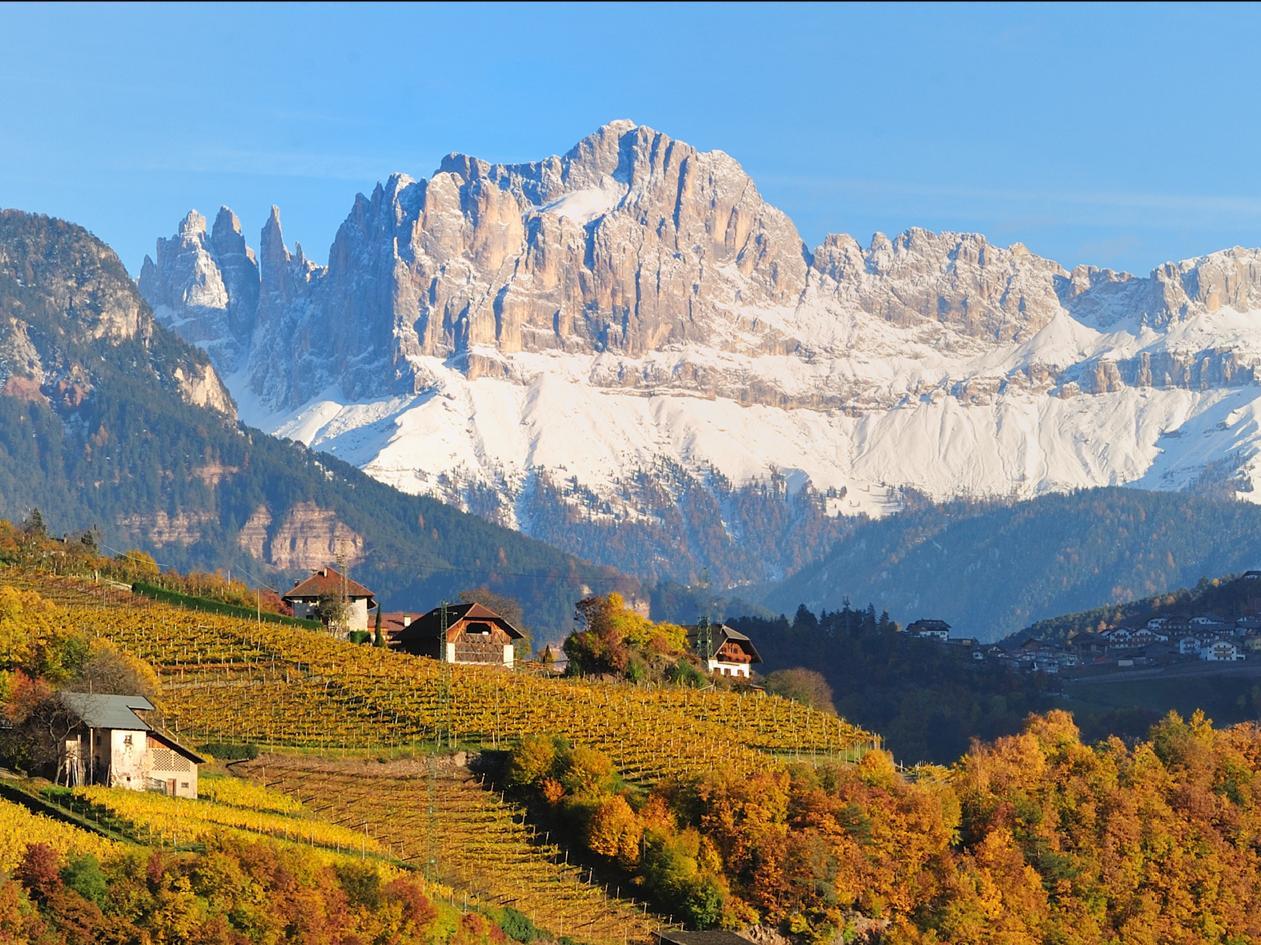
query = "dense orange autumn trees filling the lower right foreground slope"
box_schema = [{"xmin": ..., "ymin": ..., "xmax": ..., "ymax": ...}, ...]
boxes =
[{"xmin": 509, "ymin": 712, "xmax": 1261, "ymax": 945}]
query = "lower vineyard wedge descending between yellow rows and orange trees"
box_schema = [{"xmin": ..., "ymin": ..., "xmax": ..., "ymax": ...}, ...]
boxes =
[{"xmin": 236, "ymin": 754, "xmax": 666, "ymax": 945}]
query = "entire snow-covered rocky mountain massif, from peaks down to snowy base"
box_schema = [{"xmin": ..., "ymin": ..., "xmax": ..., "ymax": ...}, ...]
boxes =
[{"xmin": 140, "ymin": 121, "xmax": 1261, "ymax": 580}]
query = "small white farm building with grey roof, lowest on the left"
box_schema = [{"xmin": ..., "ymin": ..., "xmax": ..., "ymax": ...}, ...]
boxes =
[{"xmin": 57, "ymin": 693, "xmax": 203, "ymax": 797}]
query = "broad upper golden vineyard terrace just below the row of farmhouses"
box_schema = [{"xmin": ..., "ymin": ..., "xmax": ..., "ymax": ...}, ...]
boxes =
[{"xmin": 7, "ymin": 572, "xmax": 876, "ymax": 784}]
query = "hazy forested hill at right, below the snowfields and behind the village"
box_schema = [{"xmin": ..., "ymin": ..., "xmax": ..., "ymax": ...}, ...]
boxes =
[{"xmin": 763, "ymin": 488, "xmax": 1261, "ymax": 641}]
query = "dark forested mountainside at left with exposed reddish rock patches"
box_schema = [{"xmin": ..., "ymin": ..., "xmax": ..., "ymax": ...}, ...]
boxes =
[{"xmin": 0, "ymin": 211, "xmax": 638, "ymax": 631}]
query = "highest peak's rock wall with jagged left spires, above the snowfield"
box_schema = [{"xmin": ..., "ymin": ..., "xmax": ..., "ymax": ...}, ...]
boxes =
[{"xmin": 140, "ymin": 121, "xmax": 808, "ymax": 408}]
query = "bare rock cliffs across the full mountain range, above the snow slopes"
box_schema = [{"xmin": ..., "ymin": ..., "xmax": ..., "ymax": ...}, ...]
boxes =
[{"xmin": 140, "ymin": 121, "xmax": 1261, "ymax": 410}]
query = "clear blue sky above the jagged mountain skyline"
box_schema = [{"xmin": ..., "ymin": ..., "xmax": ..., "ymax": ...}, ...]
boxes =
[{"xmin": 0, "ymin": 4, "xmax": 1261, "ymax": 273}]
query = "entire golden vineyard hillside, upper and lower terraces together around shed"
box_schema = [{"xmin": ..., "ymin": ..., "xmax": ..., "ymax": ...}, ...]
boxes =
[{"xmin": 0, "ymin": 570, "xmax": 876, "ymax": 945}]
